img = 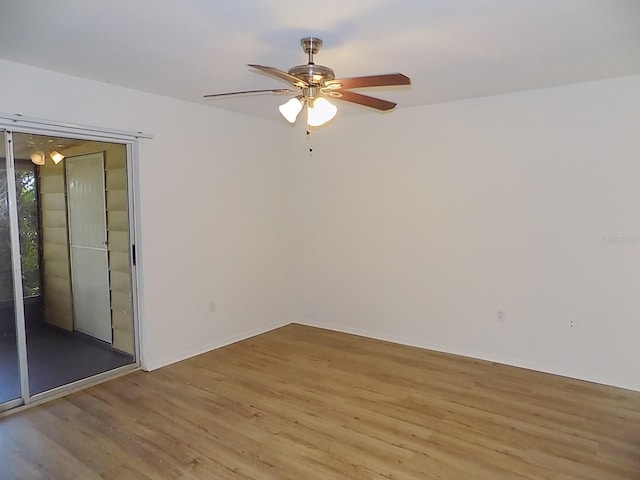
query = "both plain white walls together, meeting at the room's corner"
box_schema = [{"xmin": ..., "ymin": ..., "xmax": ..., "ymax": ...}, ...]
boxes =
[{"xmin": 5, "ymin": 61, "xmax": 640, "ymax": 390}]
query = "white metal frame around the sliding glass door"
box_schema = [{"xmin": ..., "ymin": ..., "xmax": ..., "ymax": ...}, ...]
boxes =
[{"xmin": 0, "ymin": 113, "xmax": 153, "ymax": 414}]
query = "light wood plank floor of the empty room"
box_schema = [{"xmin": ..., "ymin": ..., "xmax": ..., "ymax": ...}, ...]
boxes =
[{"xmin": 0, "ymin": 325, "xmax": 640, "ymax": 480}]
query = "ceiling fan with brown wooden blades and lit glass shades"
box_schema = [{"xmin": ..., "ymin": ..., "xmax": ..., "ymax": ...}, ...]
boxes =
[{"xmin": 204, "ymin": 37, "xmax": 411, "ymax": 132}]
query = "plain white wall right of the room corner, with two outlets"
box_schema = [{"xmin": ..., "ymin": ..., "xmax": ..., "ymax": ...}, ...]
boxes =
[{"xmin": 291, "ymin": 76, "xmax": 640, "ymax": 390}]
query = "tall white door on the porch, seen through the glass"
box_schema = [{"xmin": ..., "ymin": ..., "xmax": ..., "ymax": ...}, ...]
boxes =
[{"xmin": 64, "ymin": 153, "xmax": 112, "ymax": 343}]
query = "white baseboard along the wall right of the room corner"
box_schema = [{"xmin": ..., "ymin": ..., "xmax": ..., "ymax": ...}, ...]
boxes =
[{"xmin": 293, "ymin": 318, "xmax": 640, "ymax": 392}]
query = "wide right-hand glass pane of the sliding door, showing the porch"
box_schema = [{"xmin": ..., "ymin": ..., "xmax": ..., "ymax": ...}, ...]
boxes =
[{"xmin": 13, "ymin": 133, "xmax": 136, "ymax": 395}]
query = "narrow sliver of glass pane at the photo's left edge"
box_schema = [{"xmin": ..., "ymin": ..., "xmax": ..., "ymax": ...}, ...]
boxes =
[{"xmin": 0, "ymin": 131, "xmax": 21, "ymax": 411}]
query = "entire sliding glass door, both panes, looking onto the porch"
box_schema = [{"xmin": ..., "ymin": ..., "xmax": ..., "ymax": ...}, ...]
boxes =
[{"xmin": 0, "ymin": 126, "xmax": 139, "ymax": 410}]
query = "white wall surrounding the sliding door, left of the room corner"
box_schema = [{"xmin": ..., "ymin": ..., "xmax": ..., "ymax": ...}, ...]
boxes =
[{"xmin": 0, "ymin": 61, "xmax": 289, "ymax": 368}]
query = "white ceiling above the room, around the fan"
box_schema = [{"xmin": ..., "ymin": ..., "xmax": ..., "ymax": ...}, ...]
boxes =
[{"xmin": 0, "ymin": 0, "xmax": 640, "ymax": 119}]
